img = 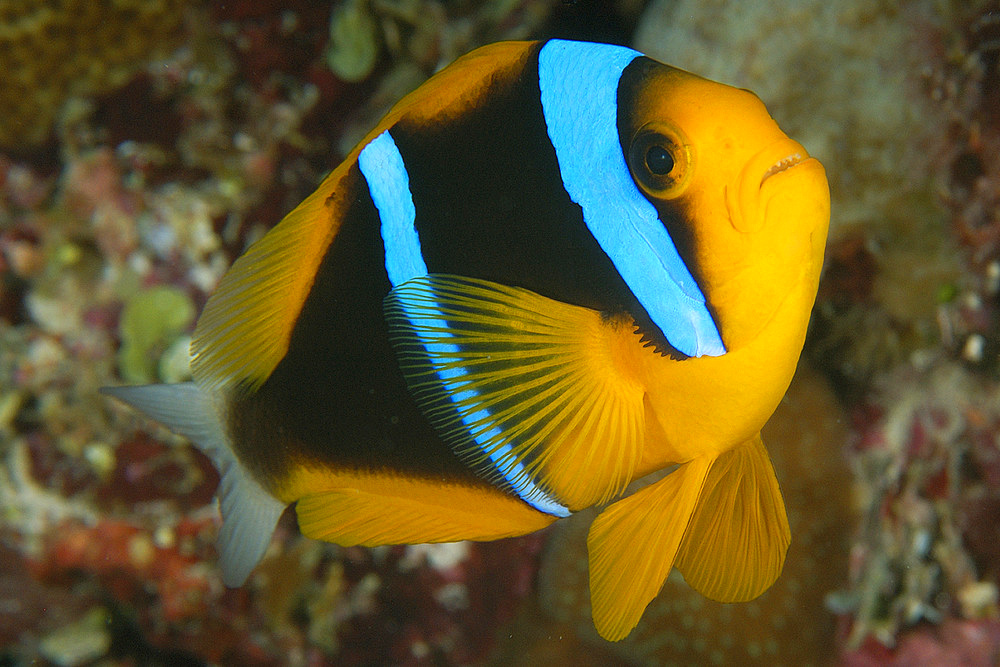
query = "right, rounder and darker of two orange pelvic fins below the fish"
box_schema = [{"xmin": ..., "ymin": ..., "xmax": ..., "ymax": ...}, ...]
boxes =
[{"xmin": 676, "ymin": 434, "xmax": 792, "ymax": 602}]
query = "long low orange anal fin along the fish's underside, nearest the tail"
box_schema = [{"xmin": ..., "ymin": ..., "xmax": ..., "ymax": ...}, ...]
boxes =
[{"xmin": 295, "ymin": 488, "xmax": 555, "ymax": 547}]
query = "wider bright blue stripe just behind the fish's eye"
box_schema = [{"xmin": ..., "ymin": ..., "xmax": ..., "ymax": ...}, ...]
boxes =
[{"xmin": 538, "ymin": 40, "xmax": 726, "ymax": 357}]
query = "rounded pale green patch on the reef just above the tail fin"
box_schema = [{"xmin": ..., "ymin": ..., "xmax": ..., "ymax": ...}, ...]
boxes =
[{"xmin": 118, "ymin": 286, "xmax": 195, "ymax": 384}]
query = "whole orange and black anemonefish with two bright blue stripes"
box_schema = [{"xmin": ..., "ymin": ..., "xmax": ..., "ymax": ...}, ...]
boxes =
[{"xmin": 106, "ymin": 40, "xmax": 829, "ymax": 640}]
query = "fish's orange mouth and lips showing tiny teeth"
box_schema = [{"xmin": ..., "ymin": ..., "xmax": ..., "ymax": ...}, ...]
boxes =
[{"xmin": 726, "ymin": 137, "xmax": 816, "ymax": 232}]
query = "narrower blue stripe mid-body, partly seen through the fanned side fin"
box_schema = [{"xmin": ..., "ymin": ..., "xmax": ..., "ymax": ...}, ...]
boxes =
[{"xmin": 358, "ymin": 130, "xmax": 570, "ymax": 517}]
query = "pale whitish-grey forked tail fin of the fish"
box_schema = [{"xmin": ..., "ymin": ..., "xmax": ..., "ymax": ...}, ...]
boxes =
[{"xmin": 101, "ymin": 382, "xmax": 285, "ymax": 586}]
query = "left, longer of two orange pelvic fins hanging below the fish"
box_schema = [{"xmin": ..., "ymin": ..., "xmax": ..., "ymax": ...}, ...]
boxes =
[{"xmin": 587, "ymin": 458, "xmax": 712, "ymax": 641}]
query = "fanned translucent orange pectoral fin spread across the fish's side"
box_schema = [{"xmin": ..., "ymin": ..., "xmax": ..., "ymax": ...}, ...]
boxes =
[{"xmin": 385, "ymin": 274, "xmax": 644, "ymax": 515}]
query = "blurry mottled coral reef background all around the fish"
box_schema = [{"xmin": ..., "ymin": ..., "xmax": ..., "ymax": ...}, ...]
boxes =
[{"xmin": 0, "ymin": 0, "xmax": 1000, "ymax": 665}]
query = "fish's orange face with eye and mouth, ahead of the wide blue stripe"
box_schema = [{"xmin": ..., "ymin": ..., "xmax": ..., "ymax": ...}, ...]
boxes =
[{"xmin": 619, "ymin": 61, "xmax": 830, "ymax": 352}]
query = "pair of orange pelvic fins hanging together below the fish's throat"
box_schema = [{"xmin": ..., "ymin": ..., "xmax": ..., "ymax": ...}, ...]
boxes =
[{"xmin": 587, "ymin": 435, "xmax": 791, "ymax": 641}]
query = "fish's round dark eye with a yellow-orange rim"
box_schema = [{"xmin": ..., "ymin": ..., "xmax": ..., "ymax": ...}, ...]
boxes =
[{"xmin": 628, "ymin": 123, "xmax": 691, "ymax": 199}]
